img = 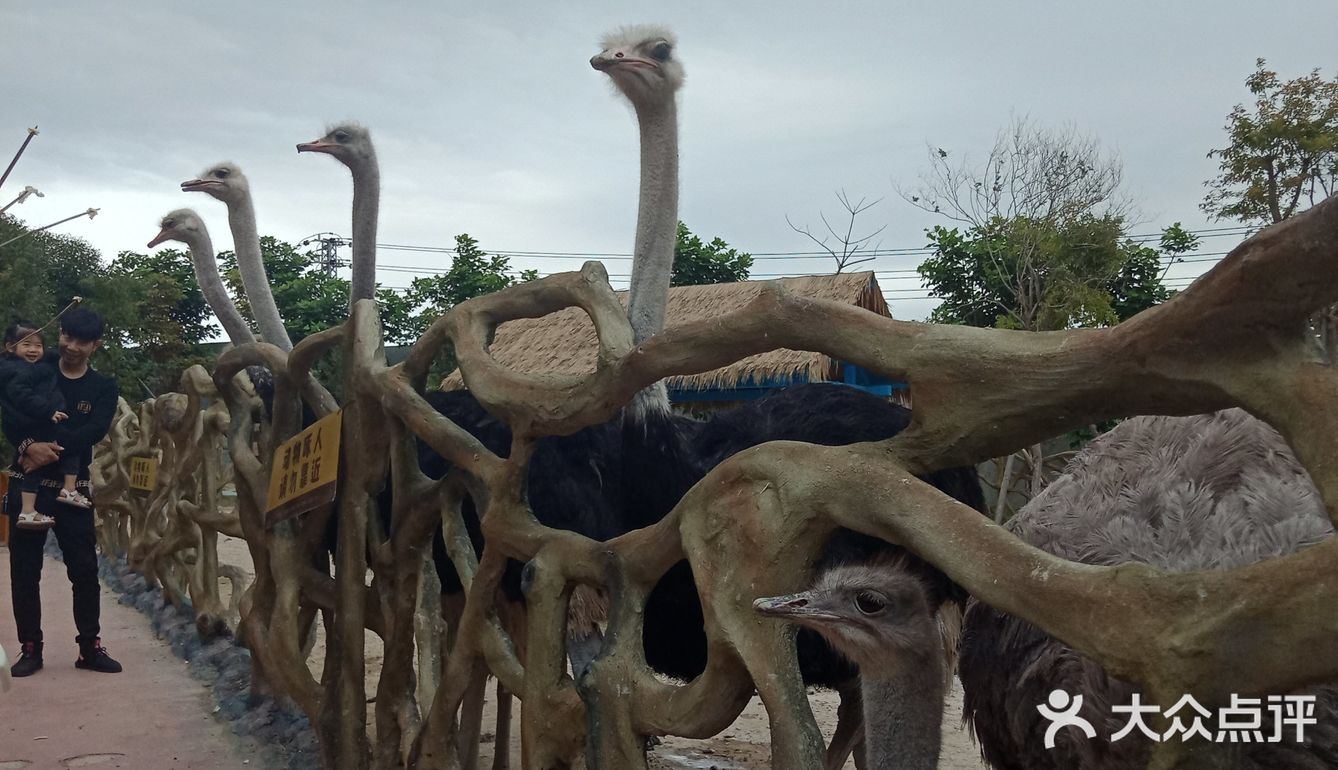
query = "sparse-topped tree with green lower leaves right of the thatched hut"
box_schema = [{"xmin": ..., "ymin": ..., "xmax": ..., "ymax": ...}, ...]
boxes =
[{"xmin": 902, "ymin": 119, "xmax": 1192, "ymax": 331}]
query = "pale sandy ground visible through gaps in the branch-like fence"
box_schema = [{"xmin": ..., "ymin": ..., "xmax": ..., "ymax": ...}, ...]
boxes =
[{"xmin": 218, "ymin": 536, "xmax": 986, "ymax": 770}]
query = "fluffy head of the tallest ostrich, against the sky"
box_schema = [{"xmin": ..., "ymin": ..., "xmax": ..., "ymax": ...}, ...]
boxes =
[{"xmin": 590, "ymin": 24, "xmax": 684, "ymax": 108}]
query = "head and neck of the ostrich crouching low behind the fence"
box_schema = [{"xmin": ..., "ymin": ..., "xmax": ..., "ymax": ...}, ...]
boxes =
[{"xmin": 753, "ymin": 557, "xmax": 950, "ymax": 770}]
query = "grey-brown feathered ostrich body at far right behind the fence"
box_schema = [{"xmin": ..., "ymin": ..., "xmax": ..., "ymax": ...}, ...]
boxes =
[{"xmin": 959, "ymin": 410, "xmax": 1338, "ymax": 770}]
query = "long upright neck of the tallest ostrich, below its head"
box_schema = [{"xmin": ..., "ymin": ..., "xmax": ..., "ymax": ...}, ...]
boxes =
[{"xmin": 628, "ymin": 99, "xmax": 678, "ymax": 344}]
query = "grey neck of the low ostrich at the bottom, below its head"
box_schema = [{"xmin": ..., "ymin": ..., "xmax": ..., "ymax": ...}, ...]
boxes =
[{"xmin": 860, "ymin": 649, "xmax": 947, "ymax": 770}]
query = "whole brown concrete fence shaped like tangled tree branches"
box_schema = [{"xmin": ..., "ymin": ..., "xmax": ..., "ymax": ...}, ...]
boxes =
[{"xmin": 91, "ymin": 198, "xmax": 1338, "ymax": 769}]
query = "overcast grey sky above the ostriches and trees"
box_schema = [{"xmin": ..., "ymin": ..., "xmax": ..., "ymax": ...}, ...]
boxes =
[{"xmin": 0, "ymin": 0, "xmax": 1338, "ymax": 325}]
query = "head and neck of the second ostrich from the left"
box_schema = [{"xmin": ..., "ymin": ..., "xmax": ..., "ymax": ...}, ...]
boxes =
[{"xmin": 181, "ymin": 163, "xmax": 293, "ymax": 352}]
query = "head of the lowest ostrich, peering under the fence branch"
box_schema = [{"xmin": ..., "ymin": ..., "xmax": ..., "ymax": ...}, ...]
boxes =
[{"xmin": 753, "ymin": 561, "xmax": 942, "ymax": 671}]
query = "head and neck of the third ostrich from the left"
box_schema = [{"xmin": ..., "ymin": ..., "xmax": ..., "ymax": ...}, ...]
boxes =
[{"xmin": 297, "ymin": 123, "xmax": 381, "ymax": 309}]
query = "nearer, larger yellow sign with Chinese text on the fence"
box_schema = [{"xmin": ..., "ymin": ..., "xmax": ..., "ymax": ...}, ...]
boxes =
[{"xmin": 265, "ymin": 410, "xmax": 344, "ymax": 526}]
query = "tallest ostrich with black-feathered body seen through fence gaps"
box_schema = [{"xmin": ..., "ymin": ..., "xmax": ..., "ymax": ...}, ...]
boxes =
[{"xmin": 396, "ymin": 27, "xmax": 982, "ymax": 765}]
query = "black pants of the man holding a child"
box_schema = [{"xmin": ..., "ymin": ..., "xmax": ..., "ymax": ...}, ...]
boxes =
[{"xmin": 4, "ymin": 487, "xmax": 102, "ymax": 644}]
